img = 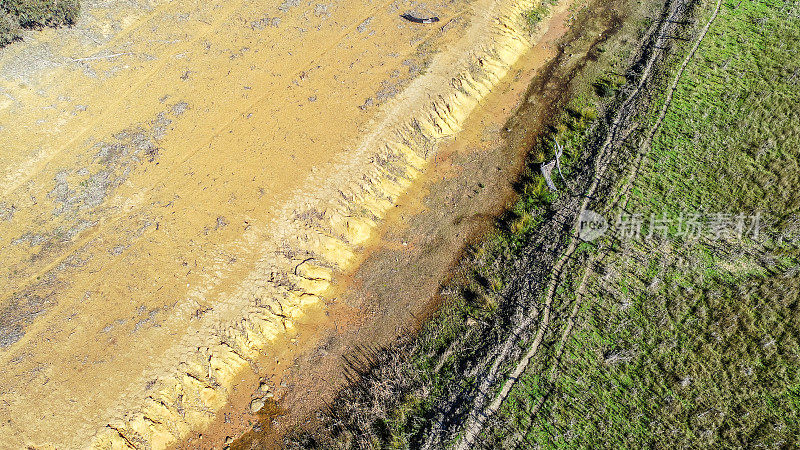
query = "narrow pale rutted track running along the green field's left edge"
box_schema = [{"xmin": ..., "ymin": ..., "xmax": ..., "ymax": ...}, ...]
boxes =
[{"xmin": 428, "ymin": 1, "xmax": 691, "ymax": 448}]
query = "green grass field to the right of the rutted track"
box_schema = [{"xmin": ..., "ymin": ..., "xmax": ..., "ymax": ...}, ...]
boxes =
[{"xmin": 484, "ymin": 1, "xmax": 800, "ymax": 448}]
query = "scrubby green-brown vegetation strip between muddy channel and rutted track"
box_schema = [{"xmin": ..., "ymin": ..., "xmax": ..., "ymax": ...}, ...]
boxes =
[{"xmin": 278, "ymin": 2, "xmax": 680, "ymax": 442}]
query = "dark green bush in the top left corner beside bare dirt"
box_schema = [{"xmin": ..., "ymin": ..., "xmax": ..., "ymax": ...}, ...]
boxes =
[{"xmin": 0, "ymin": 0, "xmax": 80, "ymax": 47}]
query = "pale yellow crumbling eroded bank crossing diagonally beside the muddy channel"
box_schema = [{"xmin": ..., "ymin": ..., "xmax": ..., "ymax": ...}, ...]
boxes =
[{"xmin": 78, "ymin": 1, "xmax": 565, "ymax": 448}]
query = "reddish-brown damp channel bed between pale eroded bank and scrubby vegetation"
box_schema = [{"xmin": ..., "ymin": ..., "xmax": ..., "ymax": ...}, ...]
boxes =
[{"xmin": 222, "ymin": 4, "xmax": 578, "ymax": 449}]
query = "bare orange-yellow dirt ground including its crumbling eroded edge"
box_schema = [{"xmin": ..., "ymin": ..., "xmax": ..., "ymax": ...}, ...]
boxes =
[{"xmin": 0, "ymin": 0, "xmax": 580, "ymax": 448}]
